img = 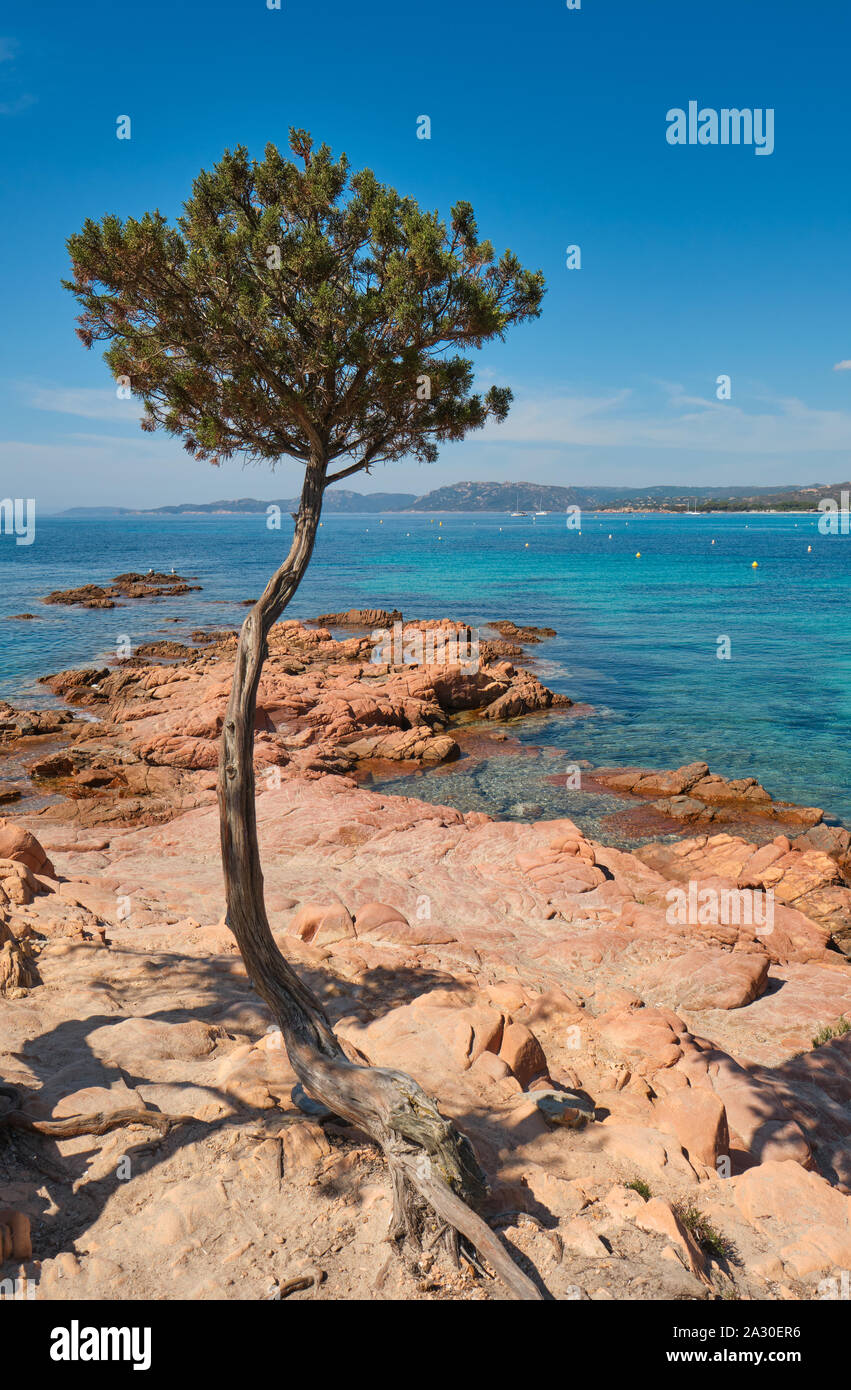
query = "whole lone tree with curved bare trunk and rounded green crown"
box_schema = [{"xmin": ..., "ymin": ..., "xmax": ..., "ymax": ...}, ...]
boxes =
[{"xmin": 64, "ymin": 131, "xmax": 544, "ymax": 1298}]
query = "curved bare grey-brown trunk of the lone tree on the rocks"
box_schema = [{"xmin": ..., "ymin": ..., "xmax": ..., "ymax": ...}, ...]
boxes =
[{"xmin": 218, "ymin": 457, "xmax": 541, "ymax": 1300}]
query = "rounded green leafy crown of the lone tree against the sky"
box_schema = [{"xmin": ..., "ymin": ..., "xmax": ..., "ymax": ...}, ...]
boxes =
[{"xmin": 63, "ymin": 131, "xmax": 544, "ymax": 482}]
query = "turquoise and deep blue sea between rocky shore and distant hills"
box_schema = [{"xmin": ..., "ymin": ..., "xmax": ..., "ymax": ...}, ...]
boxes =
[{"xmin": 0, "ymin": 513, "xmax": 851, "ymax": 823}]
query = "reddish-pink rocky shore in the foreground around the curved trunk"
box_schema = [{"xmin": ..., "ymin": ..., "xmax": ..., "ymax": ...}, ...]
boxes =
[{"xmin": 0, "ymin": 608, "xmax": 851, "ymax": 1298}]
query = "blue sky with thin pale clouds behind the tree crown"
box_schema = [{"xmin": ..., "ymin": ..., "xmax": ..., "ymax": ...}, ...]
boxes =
[{"xmin": 0, "ymin": 0, "xmax": 851, "ymax": 510}]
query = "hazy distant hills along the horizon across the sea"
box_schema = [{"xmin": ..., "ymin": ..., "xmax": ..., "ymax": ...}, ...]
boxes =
[{"xmin": 61, "ymin": 482, "xmax": 851, "ymax": 517}]
